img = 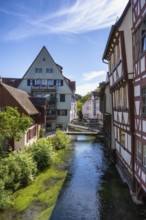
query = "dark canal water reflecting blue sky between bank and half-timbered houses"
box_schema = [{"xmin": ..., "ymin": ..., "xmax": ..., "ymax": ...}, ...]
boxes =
[{"xmin": 50, "ymin": 135, "xmax": 144, "ymax": 220}]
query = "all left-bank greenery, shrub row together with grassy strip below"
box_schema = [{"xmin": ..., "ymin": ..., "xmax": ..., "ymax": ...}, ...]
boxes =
[{"xmin": 0, "ymin": 130, "xmax": 70, "ymax": 219}]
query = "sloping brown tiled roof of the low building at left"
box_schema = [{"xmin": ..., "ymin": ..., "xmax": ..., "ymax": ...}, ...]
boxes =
[{"xmin": 1, "ymin": 83, "xmax": 38, "ymax": 115}]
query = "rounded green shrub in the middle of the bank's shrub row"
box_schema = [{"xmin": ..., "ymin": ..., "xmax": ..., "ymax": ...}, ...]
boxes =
[{"xmin": 28, "ymin": 138, "xmax": 54, "ymax": 170}]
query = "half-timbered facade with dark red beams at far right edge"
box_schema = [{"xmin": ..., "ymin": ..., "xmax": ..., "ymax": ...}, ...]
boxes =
[{"xmin": 131, "ymin": 0, "xmax": 146, "ymax": 200}]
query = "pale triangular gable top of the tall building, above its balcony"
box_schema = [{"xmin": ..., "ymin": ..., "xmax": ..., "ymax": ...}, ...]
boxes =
[{"xmin": 18, "ymin": 47, "xmax": 72, "ymax": 94}]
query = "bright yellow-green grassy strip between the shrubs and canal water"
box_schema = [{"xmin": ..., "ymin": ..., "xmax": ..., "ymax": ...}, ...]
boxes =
[{"xmin": 9, "ymin": 149, "xmax": 71, "ymax": 220}]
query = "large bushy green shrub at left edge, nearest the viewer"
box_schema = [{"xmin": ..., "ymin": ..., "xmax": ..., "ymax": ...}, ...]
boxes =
[{"xmin": 0, "ymin": 151, "xmax": 37, "ymax": 191}]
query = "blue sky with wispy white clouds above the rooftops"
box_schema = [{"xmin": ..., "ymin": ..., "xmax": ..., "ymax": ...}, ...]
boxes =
[{"xmin": 0, "ymin": 0, "xmax": 128, "ymax": 95}]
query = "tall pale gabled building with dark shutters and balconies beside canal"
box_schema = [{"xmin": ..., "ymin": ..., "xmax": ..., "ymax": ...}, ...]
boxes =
[{"xmin": 18, "ymin": 47, "xmax": 76, "ymax": 130}]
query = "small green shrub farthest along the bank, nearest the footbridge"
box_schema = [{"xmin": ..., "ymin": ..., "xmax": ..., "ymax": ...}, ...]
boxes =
[{"xmin": 51, "ymin": 129, "xmax": 70, "ymax": 150}]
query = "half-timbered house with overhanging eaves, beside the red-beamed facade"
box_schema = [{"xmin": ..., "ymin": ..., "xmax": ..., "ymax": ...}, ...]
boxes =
[{"xmin": 103, "ymin": 1, "xmax": 134, "ymax": 191}]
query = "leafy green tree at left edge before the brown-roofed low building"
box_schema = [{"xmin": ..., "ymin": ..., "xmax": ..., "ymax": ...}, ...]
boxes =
[{"xmin": 0, "ymin": 106, "xmax": 32, "ymax": 152}]
